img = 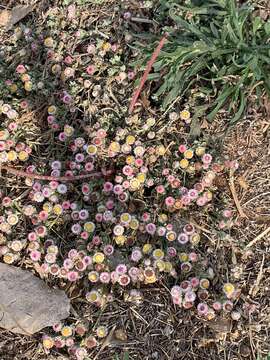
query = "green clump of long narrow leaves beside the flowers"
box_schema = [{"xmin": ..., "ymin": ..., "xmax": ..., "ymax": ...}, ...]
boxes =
[{"xmin": 136, "ymin": 0, "xmax": 270, "ymax": 124}]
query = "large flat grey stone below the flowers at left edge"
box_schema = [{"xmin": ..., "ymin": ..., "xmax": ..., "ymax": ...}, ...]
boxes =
[{"xmin": 0, "ymin": 263, "xmax": 70, "ymax": 335}]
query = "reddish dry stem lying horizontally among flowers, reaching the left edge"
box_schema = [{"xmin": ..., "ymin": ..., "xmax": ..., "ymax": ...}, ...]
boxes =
[{"xmin": 1, "ymin": 165, "xmax": 113, "ymax": 181}]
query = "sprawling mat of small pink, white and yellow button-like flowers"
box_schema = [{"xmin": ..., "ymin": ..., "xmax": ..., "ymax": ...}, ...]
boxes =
[{"xmin": 0, "ymin": 1, "xmax": 268, "ymax": 359}]
